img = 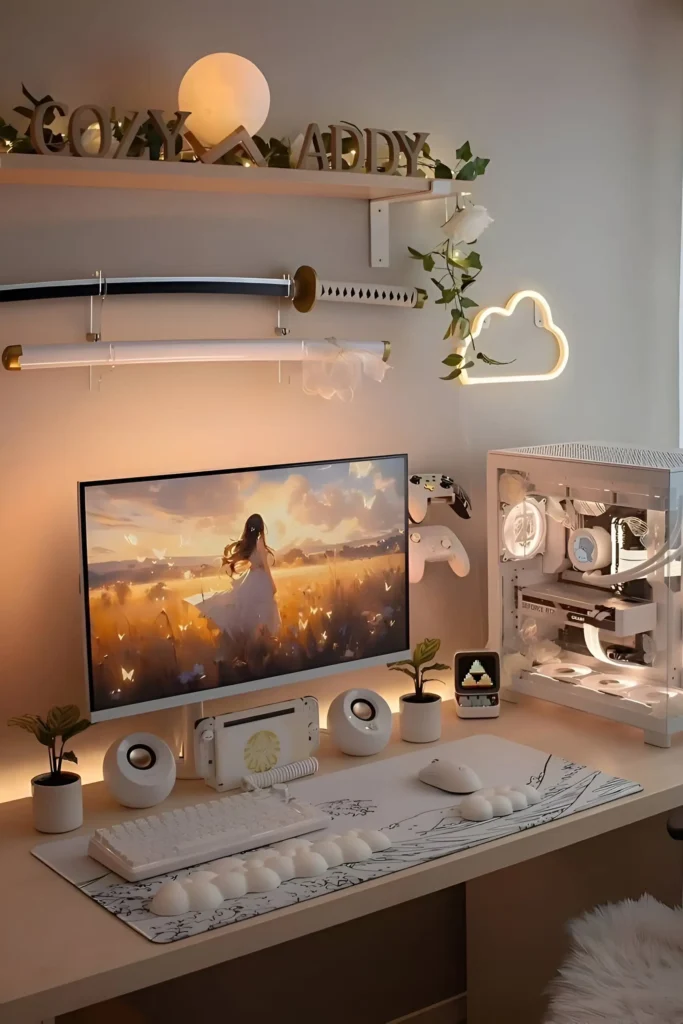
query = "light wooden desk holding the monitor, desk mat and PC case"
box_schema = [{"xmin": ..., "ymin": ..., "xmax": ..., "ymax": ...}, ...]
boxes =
[{"xmin": 0, "ymin": 699, "xmax": 683, "ymax": 1024}]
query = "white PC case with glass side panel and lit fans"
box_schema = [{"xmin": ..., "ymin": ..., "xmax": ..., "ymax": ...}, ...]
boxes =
[{"xmin": 487, "ymin": 443, "xmax": 683, "ymax": 746}]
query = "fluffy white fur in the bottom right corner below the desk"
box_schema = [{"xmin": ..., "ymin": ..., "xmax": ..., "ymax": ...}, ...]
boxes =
[{"xmin": 546, "ymin": 896, "xmax": 683, "ymax": 1024}]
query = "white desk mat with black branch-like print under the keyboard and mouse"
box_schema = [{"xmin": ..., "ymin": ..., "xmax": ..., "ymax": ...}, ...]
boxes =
[{"xmin": 33, "ymin": 735, "xmax": 642, "ymax": 942}]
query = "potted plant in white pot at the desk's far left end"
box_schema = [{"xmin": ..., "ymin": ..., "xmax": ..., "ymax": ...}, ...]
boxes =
[{"xmin": 7, "ymin": 705, "xmax": 90, "ymax": 833}]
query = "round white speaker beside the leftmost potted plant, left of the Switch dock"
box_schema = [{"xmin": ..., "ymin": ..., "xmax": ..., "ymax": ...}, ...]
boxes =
[{"xmin": 103, "ymin": 732, "xmax": 175, "ymax": 807}]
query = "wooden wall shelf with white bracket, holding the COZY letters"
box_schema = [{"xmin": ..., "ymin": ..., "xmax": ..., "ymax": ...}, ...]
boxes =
[{"xmin": 0, "ymin": 153, "xmax": 472, "ymax": 267}]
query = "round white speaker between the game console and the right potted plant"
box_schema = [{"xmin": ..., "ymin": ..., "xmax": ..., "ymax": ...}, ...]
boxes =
[{"xmin": 328, "ymin": 690, "xmax": 391, "ymax": 757}]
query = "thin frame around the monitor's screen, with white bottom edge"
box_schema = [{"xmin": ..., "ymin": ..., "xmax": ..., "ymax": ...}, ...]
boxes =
[{"xmin": 78, "ymin": 452, "xmax": 412, "ymax": 723}]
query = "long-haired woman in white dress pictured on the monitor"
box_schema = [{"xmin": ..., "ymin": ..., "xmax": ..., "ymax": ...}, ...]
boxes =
[{"xmin": 197, "ymin": 513, "xmax": 281, "ymax": 637}]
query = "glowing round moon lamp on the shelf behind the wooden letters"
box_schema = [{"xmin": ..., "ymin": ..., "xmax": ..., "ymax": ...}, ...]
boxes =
[{"xmin": 178, "ymin": 53, "xmax": 270, "ymax": 146}]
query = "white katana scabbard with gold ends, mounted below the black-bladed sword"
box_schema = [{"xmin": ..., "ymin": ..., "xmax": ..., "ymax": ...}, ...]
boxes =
[{"xmin": 2, "ymin": 339, "xmax": 391, "ymax": 370}]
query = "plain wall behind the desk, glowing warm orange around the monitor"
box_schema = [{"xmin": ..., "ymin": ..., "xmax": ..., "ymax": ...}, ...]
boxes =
[{"xmin": 0, "ymin": 0, "xmax": 683, "ymax": 800}]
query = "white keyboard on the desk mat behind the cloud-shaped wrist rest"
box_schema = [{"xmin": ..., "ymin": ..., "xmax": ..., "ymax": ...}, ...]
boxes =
[{"xmin": 88, "ymin": 791, "xmax": 330, "ymax": 882}]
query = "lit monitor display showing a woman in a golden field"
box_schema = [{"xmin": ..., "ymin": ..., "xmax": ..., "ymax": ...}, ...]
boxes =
[{"xmin": 79, "ymin": 455, "xmax": 409, "ymax": 721}]
